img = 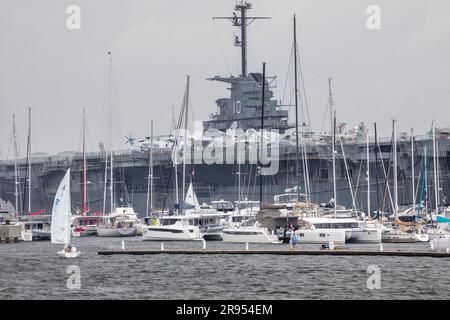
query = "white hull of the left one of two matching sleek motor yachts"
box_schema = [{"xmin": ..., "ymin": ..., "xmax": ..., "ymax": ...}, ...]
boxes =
[{"xmin": 142, "ymin": 226, "xmax": 202, "ymax": 241}]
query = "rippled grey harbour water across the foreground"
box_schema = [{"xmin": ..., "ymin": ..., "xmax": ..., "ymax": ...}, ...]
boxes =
[{"xmin": 0, "ymin": 237, "xmax": 450, "ymax": 299}]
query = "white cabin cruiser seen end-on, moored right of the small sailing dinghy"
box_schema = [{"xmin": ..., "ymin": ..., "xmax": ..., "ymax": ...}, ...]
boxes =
[{"xmin": 97, "ymin": 206, "xmax": 142, "ymax": 237}]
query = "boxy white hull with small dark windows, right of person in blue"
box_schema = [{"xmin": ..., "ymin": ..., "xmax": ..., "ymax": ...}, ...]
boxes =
[{"xmin": 295, "ymin": 229, "xmax": 351, "ymax": 244}]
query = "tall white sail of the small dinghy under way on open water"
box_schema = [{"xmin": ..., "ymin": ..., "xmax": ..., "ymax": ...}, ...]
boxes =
[{"xmin": 51, "ymin": 169, "xmax": 71, "ymax": 244}]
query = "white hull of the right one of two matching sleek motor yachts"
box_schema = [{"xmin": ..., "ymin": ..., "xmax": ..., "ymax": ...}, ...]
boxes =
[{"xmin": 222, "ymin": 228, "xmax": 280, "ymax": 243}]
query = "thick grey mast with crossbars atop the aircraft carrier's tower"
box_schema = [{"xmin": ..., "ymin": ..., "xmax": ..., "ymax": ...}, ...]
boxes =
[{"xmin": 213, "ymin": 1, "xmax": 270, "ymax": 77}]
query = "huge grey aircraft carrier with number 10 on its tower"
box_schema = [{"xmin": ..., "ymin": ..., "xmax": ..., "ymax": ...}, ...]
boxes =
[{"xmin": 0, "ymin": 3, "xmax": 450, "ymax": 215}]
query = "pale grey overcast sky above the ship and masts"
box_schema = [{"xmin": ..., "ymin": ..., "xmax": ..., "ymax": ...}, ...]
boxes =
[{"xmin": 0, "ymin": 0, "xmax": 450, "ymax": 158}]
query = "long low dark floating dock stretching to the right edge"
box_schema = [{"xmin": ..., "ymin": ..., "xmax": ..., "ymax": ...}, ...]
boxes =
[{"xmin": 98, "ymin": 249, "xmax": 450, "ymax": 258}]
